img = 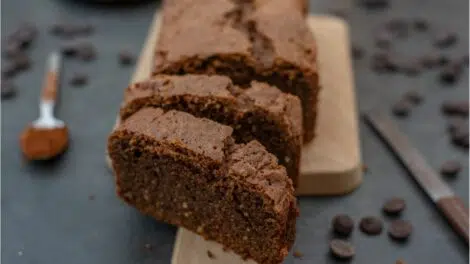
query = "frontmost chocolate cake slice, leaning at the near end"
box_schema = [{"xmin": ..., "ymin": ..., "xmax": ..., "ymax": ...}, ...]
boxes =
[{"xmin": 108, "ymin": 108, "xmax": 298, "ymax": 264}]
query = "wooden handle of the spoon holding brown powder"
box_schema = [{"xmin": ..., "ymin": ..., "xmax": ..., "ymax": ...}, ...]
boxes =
[{"xmin": 41, "ymin": 52, "xmax": 61, "ymax": 102}]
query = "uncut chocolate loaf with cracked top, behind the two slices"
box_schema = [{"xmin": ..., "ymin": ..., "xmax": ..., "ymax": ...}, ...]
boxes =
[{"xmin": 153, "ymin": 0, "xmax": 319, "ymax": 142}]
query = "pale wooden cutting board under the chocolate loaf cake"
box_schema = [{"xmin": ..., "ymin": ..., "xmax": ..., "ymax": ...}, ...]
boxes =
[{"xmin": 107, "ymin": 9, "xmax": 362, "ymax": 264}]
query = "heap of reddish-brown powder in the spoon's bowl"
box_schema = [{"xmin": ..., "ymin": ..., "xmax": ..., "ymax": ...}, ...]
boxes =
[{"xmin": 20, "ymin": 126, "xmax": 68, "ymax": 160}]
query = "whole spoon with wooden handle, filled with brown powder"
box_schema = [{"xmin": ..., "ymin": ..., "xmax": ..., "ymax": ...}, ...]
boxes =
[{"xmin": 20, "ymin": 52, "xmax": 69, "ymax": 160}]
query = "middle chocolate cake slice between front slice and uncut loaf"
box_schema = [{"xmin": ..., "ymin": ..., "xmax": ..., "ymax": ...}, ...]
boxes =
[{"xmin": 121, "ymin": 75, "xmax": 302, "ymax": 186}]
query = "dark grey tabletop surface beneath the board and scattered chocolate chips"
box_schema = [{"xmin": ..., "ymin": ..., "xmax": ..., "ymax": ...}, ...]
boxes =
[{"xmin": 1, "ymin": 0, "xmax": 469, "ymax": 264}]
